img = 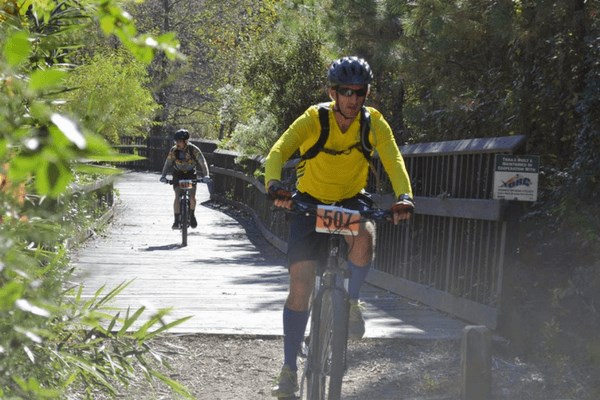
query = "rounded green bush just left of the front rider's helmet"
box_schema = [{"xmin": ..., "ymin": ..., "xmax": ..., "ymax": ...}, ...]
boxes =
[{"xmin": 220, "ymin": 24, "xmax": 327, "ymax": 157}]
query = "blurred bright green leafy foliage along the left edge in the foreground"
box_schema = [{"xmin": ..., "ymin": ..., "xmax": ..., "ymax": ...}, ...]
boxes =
[{"xmin": 0, "ymin": 0, "xmax": 190, "ymax": 399}]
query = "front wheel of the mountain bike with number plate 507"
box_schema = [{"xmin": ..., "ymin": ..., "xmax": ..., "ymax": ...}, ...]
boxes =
[{"xmin": 307, "ymin": 289, "xmax": 348, "ymax": 400}]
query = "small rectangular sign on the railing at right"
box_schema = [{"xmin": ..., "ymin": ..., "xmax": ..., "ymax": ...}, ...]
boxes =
[{"xmin": 493, "ymin": 154, "xmax": 540, "ymax": 201}]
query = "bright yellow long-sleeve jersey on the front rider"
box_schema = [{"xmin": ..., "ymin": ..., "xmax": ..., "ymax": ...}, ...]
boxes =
[{"xmin": 265, "ymin": 102, "xmax": 412, "ymax": 203}]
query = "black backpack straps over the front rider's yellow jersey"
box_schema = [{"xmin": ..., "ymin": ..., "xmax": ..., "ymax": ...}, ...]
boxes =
[{"xmin": 300, "ymin": 103, "xmax": 373, "ymax": 162}]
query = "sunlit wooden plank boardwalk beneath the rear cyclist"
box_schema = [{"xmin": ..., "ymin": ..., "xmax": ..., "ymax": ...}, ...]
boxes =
[{"xmin": 72, "ymin": 172, "xmax": 465, "ymax": 339}]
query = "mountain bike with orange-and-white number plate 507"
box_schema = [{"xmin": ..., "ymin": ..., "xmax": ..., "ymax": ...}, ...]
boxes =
[{"xmin": 280, "ymin": 200, "xmax": 391, "ymax": 400}]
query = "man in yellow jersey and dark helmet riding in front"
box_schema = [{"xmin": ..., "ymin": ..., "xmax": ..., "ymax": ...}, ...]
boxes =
[{"xmin": 265, "ymin": 57, "xmax": 414, "ymax": 398}]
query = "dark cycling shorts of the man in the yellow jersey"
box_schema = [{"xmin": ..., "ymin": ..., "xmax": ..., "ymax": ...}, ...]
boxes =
[{"xmin": 287, "ymin": 192, "xmax": 373, "ymax": 268}]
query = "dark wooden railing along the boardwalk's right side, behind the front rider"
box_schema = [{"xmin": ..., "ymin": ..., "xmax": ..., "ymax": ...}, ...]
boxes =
[{"xmin": 116, "ymin": 136, "xmax": 525, "ymax": 329}]
